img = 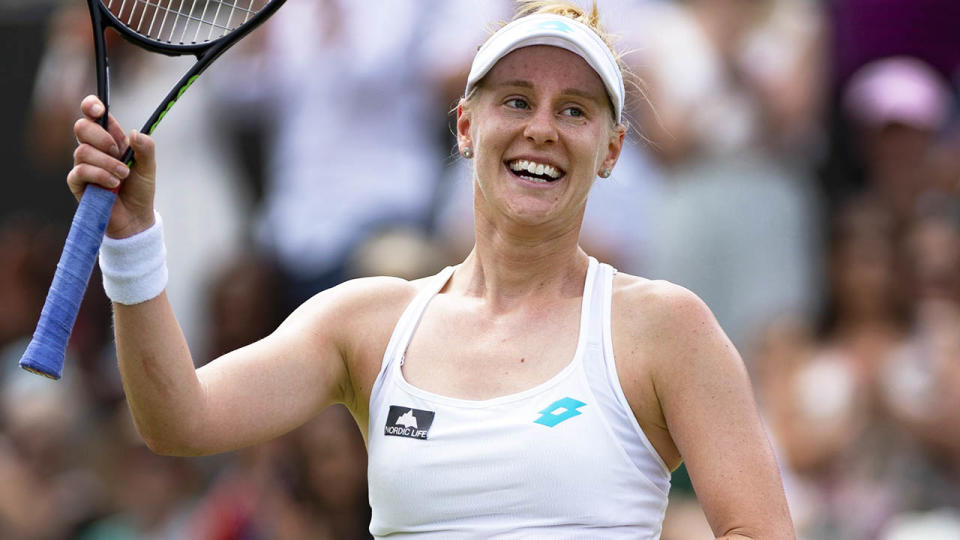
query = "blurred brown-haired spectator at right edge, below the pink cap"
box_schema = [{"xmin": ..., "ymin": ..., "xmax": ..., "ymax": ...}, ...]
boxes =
[{"xmin": 879, "ymin": 213, "xmax": 960, "ymax": 510}]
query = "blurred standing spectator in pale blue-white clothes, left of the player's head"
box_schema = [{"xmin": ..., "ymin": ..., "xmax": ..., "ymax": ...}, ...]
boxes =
[{"xmin": 222, "ymin": 0, "xmax": 510, "ymax": 310}]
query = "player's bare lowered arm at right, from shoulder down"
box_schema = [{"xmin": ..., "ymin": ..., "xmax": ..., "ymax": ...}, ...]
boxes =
[{"xmin": 614, "ymin": 281, "xmax": 795, "ymax": 539}]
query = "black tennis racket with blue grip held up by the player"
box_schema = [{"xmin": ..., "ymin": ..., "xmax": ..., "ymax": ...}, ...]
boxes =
[{"xmin": 20, "ymin": 0, "xmax": 286, "ymax": 379}]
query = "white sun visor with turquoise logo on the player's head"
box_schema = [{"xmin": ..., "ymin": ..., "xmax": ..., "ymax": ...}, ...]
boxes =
[{"xmin": 464, "ymin": 14, "xmax": 624, "ymax": 123}]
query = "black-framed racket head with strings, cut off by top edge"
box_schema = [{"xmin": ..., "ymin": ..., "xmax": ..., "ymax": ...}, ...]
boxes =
[{"xmin": 94, "ymin": 0, "xmax": 285, "ymax": 56}]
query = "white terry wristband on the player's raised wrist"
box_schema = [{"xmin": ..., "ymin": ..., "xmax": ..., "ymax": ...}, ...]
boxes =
[{"xmin": 100, "ymin": 210, "xmax": 167, "ymax": 305}]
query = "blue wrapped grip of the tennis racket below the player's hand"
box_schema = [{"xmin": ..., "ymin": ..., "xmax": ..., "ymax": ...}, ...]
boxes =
[{"xmin": 20, "ymin": 184, "xmax": 117, "ymax": 379}]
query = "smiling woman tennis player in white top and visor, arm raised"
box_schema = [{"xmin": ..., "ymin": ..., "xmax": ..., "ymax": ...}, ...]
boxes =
[{"xmin": 68, "ymin": 2, "xmax": 793, "ymax": 539}]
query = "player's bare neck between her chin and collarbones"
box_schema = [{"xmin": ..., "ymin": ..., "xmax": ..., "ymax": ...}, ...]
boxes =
[{"xmin": 458, "ymin": 192, "xmax": 587, "ymax": 311}]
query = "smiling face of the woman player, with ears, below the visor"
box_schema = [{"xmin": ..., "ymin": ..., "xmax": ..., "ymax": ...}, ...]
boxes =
[{"xmin": 457, "ymin": 46, "xmax": 625, "ymax": 230}]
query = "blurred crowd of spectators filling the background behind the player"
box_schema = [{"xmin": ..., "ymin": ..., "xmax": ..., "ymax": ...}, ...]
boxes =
[{"xmin": 0, "ymin": 0, "xmax": 960, "ymax": 540}]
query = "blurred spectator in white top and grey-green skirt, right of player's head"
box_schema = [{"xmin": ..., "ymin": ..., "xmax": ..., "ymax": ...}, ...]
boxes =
[{"xmin": 624, "ymin": 0, "xmax": 823, "ymax": 350}]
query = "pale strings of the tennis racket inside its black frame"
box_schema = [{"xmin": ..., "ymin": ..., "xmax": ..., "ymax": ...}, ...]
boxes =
[{"xmin": 101, "ymin": 0, "xmax": 269, "ymax": 45}]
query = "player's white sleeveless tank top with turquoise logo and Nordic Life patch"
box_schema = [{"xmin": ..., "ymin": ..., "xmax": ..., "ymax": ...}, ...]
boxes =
[{"xmin": 367, "ymin": 257, "xmax": 670, "ymax": 539}]
